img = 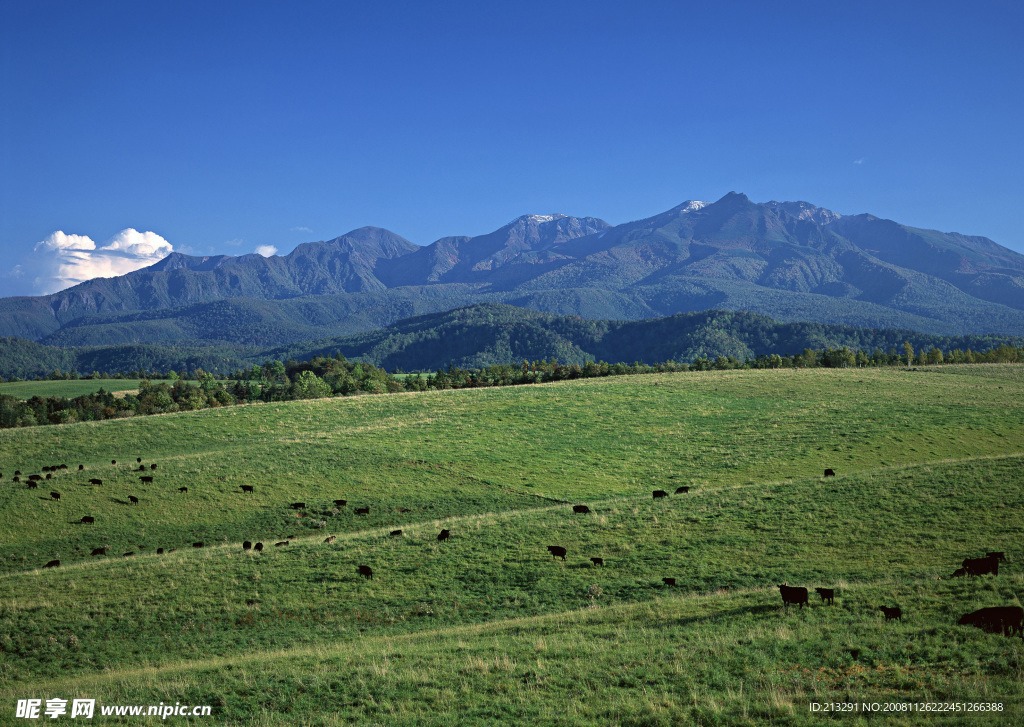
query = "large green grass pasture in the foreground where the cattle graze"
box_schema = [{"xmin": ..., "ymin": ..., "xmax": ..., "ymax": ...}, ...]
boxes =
[{"xmin": 0, "ymin": 366, "xmax": 1024, "ymax": 725}]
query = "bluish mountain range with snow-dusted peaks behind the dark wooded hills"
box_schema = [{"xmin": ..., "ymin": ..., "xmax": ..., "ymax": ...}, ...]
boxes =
[{"xmin": 0, "ymin": 193, "xmax": 1024, "ymax": 347}]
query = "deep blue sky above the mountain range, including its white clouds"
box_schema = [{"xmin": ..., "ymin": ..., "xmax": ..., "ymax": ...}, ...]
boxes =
[{"xmin": 0, "ymin": 0, "xmax": 1024, "ymax": 295}]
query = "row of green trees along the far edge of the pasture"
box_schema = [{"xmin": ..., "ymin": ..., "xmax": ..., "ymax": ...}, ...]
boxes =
[{"xmin": 0, "ymin": 342, "xmax": 1024, "ymax": 428}]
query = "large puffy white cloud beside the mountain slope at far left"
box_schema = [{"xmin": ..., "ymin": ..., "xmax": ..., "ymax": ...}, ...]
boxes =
[{"xmin": 29, "ymin": 227, "xmax": 174, "ymax": 295}]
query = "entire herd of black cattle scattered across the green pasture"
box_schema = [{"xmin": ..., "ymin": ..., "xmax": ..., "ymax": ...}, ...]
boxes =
[{"xmin": 6, "ymin": 458, "xmax": 1024, "ymax": 640}]
